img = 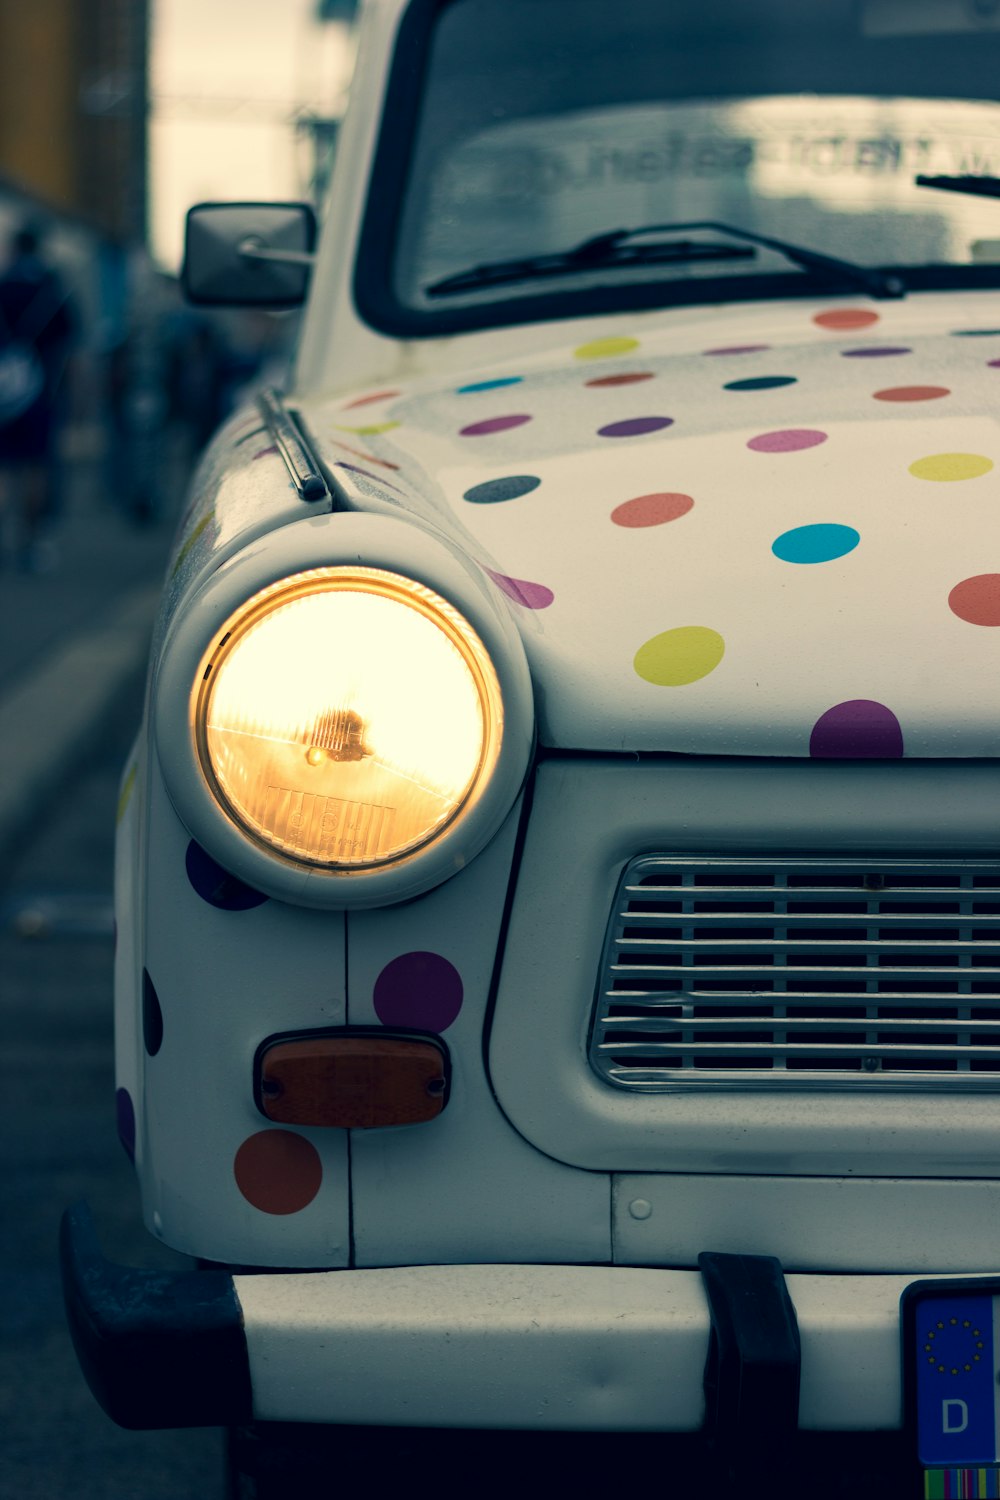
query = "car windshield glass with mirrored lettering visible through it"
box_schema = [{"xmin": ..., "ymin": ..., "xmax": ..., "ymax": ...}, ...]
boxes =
[{"xmin": 361, "ymin": 0, "xmax": 1000, "ymax": 332}]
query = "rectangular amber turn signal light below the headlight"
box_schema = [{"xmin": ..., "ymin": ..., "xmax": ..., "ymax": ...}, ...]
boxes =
[{"xmin": 253, "ymin": 1029, "xmax": 448, "ymax": 1130}]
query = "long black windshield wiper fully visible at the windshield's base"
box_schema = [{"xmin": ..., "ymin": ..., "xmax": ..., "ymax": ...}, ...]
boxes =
[{"xmin": 426, "ymin": 219, "xmax": 906, "ymax": 297}]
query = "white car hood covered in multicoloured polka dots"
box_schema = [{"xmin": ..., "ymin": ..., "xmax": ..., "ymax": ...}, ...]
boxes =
[{"xmin": 304, "ymin": 294, "xmax": 1000, "ymax": 758}]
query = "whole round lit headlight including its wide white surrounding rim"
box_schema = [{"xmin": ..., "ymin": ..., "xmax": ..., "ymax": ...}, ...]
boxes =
[{"xmin": 151, "ymin": 513, "xmax": 534, "ymax": 908}]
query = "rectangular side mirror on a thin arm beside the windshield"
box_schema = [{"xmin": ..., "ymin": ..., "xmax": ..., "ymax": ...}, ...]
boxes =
[{"xmin": 180, "ymin": 203, "xmax": 316, "ymax": 308}]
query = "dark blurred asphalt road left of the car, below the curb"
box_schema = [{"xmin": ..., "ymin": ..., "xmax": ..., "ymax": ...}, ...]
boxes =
[{"xmin": 0, "ymin": 675, "xmax": 223, "ymax": 1500}]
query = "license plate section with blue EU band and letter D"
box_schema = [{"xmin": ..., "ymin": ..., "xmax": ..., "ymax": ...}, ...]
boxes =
[{"xmin": 901, "ymin": 1277, "xmax": 1000, "ymax": 1500}]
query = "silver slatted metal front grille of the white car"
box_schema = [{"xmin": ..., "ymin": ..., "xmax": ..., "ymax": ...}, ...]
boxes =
[{"xmin": 589, "ymin": 857, "xmax": 1000, "ymax": 1092}]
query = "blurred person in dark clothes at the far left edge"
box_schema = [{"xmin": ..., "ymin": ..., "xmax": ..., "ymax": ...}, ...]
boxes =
[{"xmin": 0, "ymin": 224, "xmax": 76, "ymax": 572}]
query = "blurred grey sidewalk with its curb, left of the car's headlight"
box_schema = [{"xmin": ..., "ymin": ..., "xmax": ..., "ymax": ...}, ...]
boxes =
[{"xmin": 0, "ymin": 435, "xmax": 181, "ymax": 882}]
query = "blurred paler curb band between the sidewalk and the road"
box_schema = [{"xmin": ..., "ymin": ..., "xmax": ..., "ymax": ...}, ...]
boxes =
[{"xmin": 0, "ymin": 581, "xmax": 160, "ymax": 860}]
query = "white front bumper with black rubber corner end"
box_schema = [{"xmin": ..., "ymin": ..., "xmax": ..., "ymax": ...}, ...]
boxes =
[{"xmin": 61, "ymin": 1208, "xmax": 912, "ymax": 1433}]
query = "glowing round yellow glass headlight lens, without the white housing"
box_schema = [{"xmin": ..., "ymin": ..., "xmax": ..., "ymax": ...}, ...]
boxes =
[{"xmin": 193, "ymin": 567, "xmax": 502, "ymax": 870}]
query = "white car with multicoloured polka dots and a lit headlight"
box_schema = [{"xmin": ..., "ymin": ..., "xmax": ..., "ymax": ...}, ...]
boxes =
[{"xmin": 64, "ymin": 0, "xmax": 1000, "ymax": 1496}]
